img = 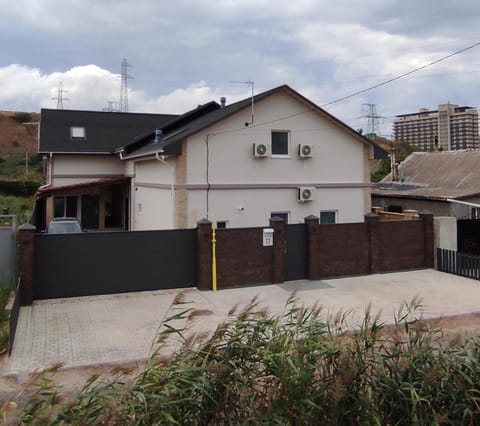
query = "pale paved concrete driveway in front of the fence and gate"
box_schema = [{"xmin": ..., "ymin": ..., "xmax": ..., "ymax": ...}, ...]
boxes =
[{"xmin": 3, "ymin": 269, "xmax": 480, "ymax": 375}]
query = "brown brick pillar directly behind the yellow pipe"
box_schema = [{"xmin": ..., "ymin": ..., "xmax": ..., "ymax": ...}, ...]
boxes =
[{"xmin": 197, "ymin": 219, "xmax": 212, "ymax": 290}]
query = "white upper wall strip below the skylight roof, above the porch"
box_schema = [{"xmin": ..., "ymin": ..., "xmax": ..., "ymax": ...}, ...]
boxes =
[{"xmin": 47, "ymin": 154, "xmax": 125, "ymax": 186}]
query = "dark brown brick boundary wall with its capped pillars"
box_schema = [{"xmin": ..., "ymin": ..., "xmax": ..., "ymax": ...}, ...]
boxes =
[{"xmin": 18, "ymin": 212, "xmax": 434, "ymax": 305}]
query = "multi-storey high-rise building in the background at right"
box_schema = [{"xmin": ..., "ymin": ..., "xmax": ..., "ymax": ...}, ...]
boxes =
[{"xmin": 393, "ymin": 104, "xmax": 480, "ymax": 151}]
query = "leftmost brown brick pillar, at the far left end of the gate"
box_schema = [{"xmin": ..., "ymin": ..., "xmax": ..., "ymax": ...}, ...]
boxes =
[{"xmin": 17, "ymin": 223, "xmax": 37, "ymax": 306}]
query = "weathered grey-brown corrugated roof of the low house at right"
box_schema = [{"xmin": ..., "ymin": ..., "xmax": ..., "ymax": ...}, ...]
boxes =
[{"xmin": 372, "ymin": 150, "xmax": 480, "ymax": 199}]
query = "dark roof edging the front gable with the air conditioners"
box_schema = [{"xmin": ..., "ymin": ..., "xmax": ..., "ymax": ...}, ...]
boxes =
[{"xmin": 119, "ymin": 85, "xmax": 384, "ymax": 157}]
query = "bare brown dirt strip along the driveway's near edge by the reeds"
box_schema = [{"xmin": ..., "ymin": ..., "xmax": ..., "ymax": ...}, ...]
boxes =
[{"xmin": 0, "ymin": 312, "xmax": 480, "ymax": 424}]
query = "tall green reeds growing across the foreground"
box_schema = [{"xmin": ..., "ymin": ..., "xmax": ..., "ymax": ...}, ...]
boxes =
[{"xmin": 3, "ymin": 296, "xmax": 480, "ymax": 425}]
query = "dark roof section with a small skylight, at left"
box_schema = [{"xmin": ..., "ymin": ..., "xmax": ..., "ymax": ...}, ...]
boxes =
[{"xmin": 38, "ymin": 109, "xmax": 177, "ymax": 154}]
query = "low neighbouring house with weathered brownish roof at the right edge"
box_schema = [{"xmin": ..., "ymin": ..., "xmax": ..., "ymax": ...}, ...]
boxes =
[{"xmin": 372, "ymin": 150, "xmax": 480, "ymax": 219}]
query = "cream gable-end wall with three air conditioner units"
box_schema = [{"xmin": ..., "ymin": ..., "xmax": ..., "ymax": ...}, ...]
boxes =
[{"xmin": 186, "ymin": 93, "xmax": 368, "ymax": 227}]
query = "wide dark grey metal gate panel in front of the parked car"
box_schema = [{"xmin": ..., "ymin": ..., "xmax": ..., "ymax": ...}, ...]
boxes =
[{"xmin": 33, "ymin": 229, "xmax": 197, "ymax": 299}]
